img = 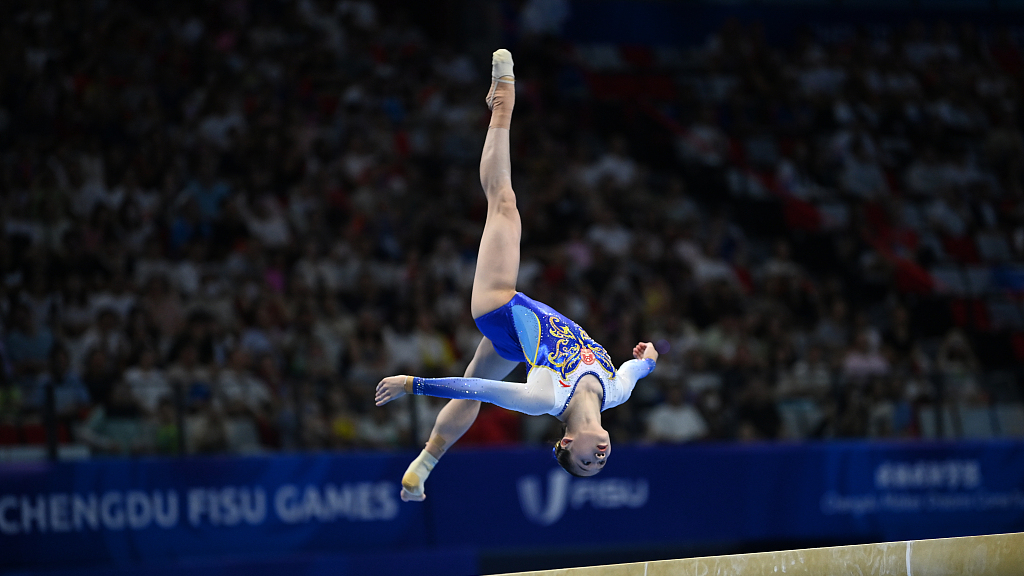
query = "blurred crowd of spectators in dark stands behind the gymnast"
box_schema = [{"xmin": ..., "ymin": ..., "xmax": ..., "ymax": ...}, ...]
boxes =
[{"xmin": 0, "ymin": 0, "xmax": 1024, "ymax": 454}]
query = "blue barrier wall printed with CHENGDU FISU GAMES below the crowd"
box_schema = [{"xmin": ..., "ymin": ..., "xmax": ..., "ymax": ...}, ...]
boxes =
[{"xmin": 0, "ymin": 441, "xmax": 1024, "ymax": 574}]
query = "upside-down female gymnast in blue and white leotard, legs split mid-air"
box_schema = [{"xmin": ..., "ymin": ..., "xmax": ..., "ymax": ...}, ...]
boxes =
[{"xmin": 376, "ymin": 48, "xmax": 657, "ymax": 501}]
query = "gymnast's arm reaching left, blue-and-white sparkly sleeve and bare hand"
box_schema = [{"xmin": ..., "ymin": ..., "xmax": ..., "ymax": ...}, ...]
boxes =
[{"xmin": 376, "ymin": 368, "xmax": 555, "ymax": 416}]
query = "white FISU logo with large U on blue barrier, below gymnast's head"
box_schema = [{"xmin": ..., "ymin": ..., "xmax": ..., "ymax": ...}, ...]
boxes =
[{"xmin": 517, "ymin": 468, "xmax": 650, "ymax": 526}]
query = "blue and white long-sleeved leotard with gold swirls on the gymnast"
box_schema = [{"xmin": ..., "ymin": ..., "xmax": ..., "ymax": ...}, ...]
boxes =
[{"xmin": 413, "ymin": 292, "xmax": 654, "ymax": 417}]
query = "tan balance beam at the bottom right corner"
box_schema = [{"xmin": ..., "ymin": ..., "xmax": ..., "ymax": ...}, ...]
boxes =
[{"xmin": 501, "ymin": 532, "xmax": 1024, "ymax": 576}]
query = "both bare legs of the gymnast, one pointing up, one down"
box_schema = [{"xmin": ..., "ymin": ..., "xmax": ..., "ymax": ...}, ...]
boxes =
[{"xmin": 401, "ymin": 49, "xmax": 522, "ymax": 501}]
